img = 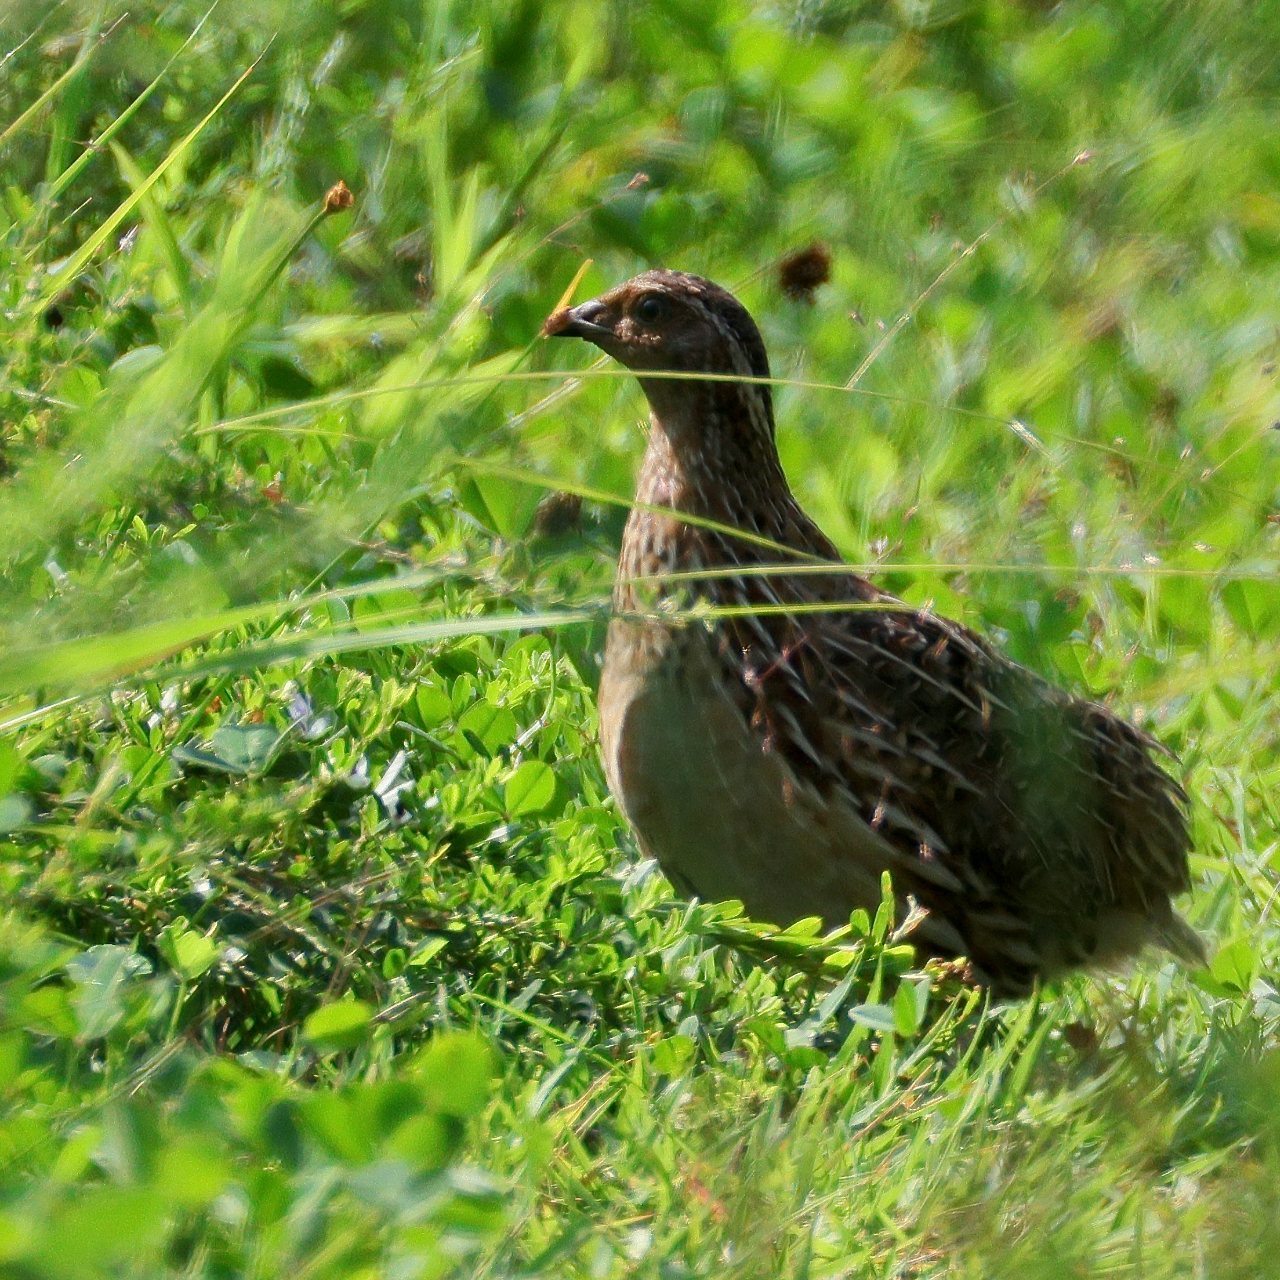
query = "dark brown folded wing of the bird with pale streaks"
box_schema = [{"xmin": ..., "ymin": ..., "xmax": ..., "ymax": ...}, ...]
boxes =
[{"xmin": 723, "ymin": 596, "xmax": 1189, "ymax": 963}]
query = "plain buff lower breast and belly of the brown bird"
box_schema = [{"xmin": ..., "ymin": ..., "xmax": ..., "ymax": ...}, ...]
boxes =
[{"xmin": 600, "ymin": 618, "xmax": 896, "ymax": 924}]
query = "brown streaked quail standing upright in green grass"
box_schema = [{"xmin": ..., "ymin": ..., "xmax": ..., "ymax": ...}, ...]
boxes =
[{"xmin": 543, "ymin": 269, "xmax": 1204, "ymax": 998}]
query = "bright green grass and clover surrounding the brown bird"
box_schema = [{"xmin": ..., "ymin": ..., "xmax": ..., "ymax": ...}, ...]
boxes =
[{"xmin": 0, "ymin": 0, "xmax": 1280, "ymax": 1280}]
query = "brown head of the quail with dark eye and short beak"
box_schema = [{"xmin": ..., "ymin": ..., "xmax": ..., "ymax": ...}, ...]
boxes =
[{"xmin": 543, "ymin": 270, "xmax": 773, "ymax": 438}]
